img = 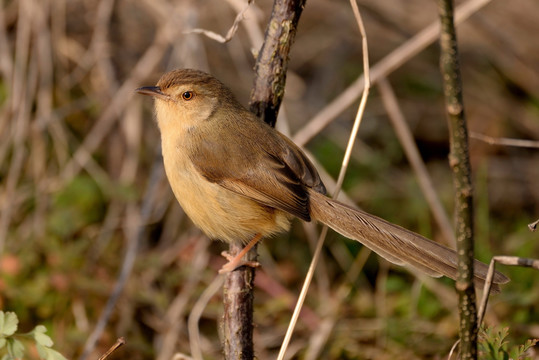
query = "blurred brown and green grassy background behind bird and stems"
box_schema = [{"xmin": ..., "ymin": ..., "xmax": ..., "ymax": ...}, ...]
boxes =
[{"xmin": 0, "ymin": 0, "xmax": 539, "ymax": 359}]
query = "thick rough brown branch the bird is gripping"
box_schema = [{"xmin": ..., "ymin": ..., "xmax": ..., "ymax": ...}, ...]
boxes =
[{"xmin": 223, "ymin": 0, "xmax": 305, "ymax": 360}]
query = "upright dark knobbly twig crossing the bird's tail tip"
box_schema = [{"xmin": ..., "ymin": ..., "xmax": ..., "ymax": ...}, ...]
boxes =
[{"xmin": 438, "ymin": 0, "xmax": 477, "ymax": 359}]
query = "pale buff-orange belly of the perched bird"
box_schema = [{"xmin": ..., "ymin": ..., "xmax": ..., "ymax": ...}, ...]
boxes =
[{"xmin": 164, "ymin": 153, "xmax": 290, "ymax": 242}]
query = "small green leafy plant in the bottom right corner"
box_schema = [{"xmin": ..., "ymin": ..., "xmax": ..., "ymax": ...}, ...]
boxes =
[{"xmin": 479, "ymin": 327, "xmax": 539, "ymax": 360}]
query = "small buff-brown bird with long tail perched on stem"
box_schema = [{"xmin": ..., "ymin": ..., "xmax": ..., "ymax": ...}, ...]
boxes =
[{"xmin": 137, "ymin": 69, "xmax": 509, "ymax": 288}]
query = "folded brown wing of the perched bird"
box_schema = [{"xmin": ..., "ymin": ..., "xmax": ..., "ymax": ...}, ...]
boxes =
[{"xmin": 190, "ymin": 118, "xmax": 325, "ymax": 221}]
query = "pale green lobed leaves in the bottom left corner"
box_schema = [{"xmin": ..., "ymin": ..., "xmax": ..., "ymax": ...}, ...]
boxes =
[{"xmin": 0, "ymin": 311, "xmax": 66, "ymax": 360}]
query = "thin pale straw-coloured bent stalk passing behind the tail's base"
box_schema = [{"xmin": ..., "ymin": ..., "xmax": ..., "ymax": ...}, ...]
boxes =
[{"xmin": 277, "ymin": 0, "xmax": 370, "ymax": 360}]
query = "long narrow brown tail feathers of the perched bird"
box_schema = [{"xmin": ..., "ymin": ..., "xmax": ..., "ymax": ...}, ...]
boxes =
[{"xmin": 309, "ymin": 190, "xmax": 509, "ymax": 291}]
